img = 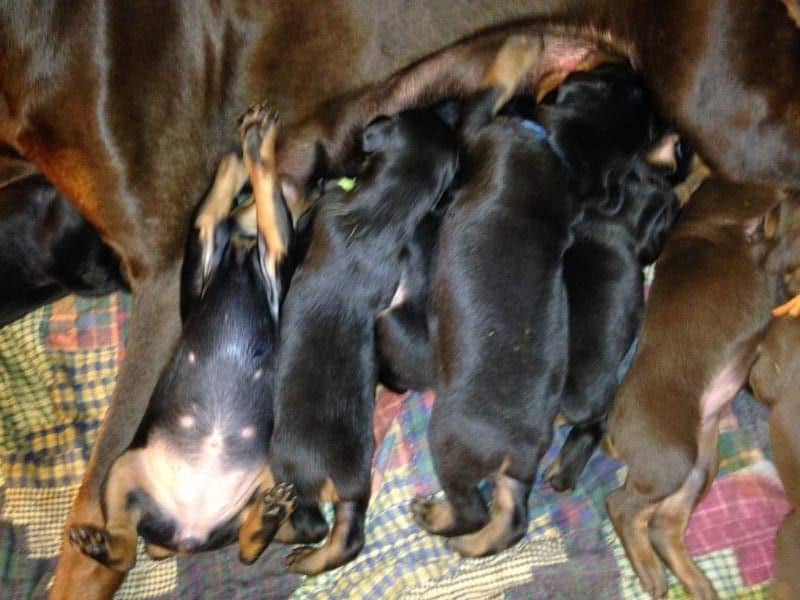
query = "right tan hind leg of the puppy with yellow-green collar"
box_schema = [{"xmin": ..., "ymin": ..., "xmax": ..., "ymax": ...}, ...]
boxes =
[{"xmin": 286, "ymin": 497, "xmax": 368, "ymax": 575}]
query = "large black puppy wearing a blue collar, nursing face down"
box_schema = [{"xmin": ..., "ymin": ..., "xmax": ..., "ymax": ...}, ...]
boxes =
[{"xmin": 412, "ymin": 65, "xmax": 684, "ymax": 556}]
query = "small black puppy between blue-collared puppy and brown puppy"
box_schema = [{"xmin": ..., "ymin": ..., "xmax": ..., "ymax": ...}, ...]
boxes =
[{"xmin": 547, "ymin": 145, "xmax": 679, "ymax": 491}]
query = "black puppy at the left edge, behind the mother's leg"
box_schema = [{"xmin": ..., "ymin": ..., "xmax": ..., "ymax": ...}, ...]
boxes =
[{"xmin": 0, "ymin": 175, "xmax": 126, "ymax": 327}]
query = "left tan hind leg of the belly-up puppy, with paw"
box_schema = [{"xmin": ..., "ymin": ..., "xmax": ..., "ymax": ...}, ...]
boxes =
[{"xmin": 69, "ymin": 450, "xmax": 141, "ymax": 573}]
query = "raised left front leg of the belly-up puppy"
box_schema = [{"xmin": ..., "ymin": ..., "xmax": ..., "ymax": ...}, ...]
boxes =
[{"xmin": 180, "ymin": 154, "xmax": 247, "ymax": 319}]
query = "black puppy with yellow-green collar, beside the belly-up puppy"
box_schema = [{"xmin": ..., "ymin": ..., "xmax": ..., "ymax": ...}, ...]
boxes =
[{"xmin": 269, "ymin": 103, "xmax": 458, "ymax": 574}]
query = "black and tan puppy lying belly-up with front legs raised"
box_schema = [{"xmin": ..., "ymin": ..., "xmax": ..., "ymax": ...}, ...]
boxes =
[{"xmin": 70, "ymin": 109, "xmax": 292, "ymax": 572}]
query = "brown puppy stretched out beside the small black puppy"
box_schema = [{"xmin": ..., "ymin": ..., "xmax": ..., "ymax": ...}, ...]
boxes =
[{"xmin": 607, "ymin": 179, "xmax": 782, "ymax": 599}]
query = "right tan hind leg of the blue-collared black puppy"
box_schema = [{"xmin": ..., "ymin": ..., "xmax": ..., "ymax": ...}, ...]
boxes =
[{"xmin": 448, "ymin": 475, "xmax": 532, "ymax": 557}]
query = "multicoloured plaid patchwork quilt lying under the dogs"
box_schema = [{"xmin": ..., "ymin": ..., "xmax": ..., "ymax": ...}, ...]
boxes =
[{"xmin": 0, "ymin": 295, "xmax": 789, "ymax": 599}]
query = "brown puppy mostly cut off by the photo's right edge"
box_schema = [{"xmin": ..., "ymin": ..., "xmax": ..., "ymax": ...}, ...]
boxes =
[{"xmin": 750, "ymin": 317, "xmax": 800, "ymax": 599}]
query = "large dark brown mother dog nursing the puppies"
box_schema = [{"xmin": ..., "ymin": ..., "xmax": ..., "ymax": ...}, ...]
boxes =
[{"xmin": 0, "ymin": 0, "xmax": 800, "ymax": 597}]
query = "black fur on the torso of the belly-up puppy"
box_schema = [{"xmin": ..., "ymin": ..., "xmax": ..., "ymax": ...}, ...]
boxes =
[{"xmin": 130, "ymin": 205, "xmax": 291, "ymax": 551}]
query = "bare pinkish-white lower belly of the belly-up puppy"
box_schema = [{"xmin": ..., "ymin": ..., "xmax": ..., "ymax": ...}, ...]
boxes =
[{"xmin": 136, "ymin": 435, "xmax": 266, "ymax": 547}]
